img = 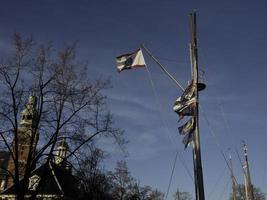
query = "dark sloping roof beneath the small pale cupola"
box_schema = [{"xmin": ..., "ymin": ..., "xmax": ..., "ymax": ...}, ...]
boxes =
[{"xmin": 1, "ymin": 163, "xmax": 78, "ymax": 198}]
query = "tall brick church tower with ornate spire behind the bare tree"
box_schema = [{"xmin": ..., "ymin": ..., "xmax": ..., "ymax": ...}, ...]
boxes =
[{"xmin": 6, "ymin": 95, "xmax": 38, "ymax": 187}]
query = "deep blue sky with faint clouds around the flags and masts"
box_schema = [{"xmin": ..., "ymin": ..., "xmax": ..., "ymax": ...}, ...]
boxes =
[{"xmin": 0, "ymin": 0, "xmax": 267, "ymax": 200}]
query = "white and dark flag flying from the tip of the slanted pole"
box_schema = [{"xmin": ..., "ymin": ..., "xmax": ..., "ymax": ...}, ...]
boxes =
[{"xmin": 116, "ymin": 49, "xmax": 146, "ymax": 72}]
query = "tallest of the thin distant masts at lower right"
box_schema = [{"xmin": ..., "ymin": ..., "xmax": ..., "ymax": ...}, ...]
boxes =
[{"xmin": 243, "ymin": 143, "xmax": 254, "ymax": 200}]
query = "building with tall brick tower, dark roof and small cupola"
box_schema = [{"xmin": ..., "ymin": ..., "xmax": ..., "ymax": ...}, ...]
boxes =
[{"xmin": 0, "ymin": 96, "xmax": 79, "ymax": 200}]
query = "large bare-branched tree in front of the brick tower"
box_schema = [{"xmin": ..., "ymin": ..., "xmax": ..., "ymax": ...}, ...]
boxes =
[{"xmin": 0, "ymin": 33, "xmax": 124, "ymax": 200}]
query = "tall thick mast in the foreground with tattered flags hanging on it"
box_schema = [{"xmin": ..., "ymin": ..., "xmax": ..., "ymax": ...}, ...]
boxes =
[{"xmin": 189, "ymin": 12, "xmax": 205, "ymax": 200}]
